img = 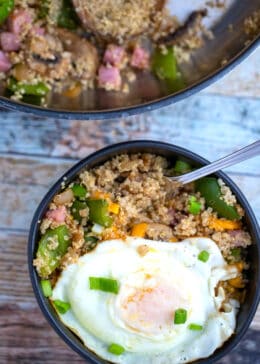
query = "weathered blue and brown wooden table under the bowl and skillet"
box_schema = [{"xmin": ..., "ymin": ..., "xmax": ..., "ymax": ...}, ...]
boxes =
[{"xmin": 0, "ymin": 50, "xmax": 260, "ymax": 364}]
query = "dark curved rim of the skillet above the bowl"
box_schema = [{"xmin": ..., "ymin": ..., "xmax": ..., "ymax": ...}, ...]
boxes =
[{"xmin": 0, "ymin": 34, "xmax": 260, "ymax": 120}]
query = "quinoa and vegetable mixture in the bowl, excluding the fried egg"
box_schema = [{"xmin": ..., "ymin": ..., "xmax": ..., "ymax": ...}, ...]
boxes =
[{"xmin": 34, "ymin": 154, "xmax": 252, "ymax": 301}]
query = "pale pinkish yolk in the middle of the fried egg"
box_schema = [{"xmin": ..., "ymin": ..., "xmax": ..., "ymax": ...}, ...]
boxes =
[{"xmin": 120, "ymin": 279, "xmax": 188, "ymax": 335}]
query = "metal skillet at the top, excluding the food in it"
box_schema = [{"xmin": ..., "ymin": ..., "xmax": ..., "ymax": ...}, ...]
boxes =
[{"xmin": 0, "ymin": 0, "xmax": 260, "ymax": 120}]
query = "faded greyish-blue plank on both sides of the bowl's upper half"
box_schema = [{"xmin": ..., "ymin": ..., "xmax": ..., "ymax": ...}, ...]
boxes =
[{"xmin": 0, "ymin": 156, "xmax": 260, "ymax": 230}]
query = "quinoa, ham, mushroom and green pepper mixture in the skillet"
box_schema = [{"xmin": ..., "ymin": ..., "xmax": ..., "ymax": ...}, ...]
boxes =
[{"xmin": 0, "ymin": 0, "xmax": 206, "ymax": 105}]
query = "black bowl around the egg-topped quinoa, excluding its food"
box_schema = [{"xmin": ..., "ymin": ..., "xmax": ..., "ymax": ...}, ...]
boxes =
[{"xmin": 28, "ymin": 140, "xmax": 260, "ymax": 364}]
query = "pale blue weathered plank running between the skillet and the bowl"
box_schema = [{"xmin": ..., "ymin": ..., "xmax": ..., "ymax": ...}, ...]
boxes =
[{"xmin": 0, "ymin": 94, "xmax": 260, "ymax": 174}]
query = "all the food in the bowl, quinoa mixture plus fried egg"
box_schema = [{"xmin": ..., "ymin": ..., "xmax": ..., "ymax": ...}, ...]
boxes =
[{"xmin": 34, "ymin": 154, "xmax": 251, "ymax": 364}]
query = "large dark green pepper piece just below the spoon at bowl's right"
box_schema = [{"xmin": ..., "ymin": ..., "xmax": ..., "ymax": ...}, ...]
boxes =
[{"xmin": 195, "ymin": 177, "xmax": 240, "ymax": 220}]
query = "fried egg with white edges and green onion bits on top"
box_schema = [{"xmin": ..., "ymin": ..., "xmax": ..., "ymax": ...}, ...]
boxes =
[{"xmin": 52, "ymin": 237, "xmax": 239, "ymax": 364}]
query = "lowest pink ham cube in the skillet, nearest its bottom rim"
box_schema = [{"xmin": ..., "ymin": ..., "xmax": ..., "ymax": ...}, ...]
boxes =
[{"xmin": 98, "ymin": 66, "xmax": 122, "ymax": 90}]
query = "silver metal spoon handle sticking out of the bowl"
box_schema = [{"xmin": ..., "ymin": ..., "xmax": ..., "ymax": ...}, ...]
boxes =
[{"xmin": 169, "ymin": 140, "xmax": 260, "ymax": 185}]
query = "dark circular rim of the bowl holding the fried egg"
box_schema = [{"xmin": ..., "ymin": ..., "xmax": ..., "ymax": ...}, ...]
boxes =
[{"xmin": 27, "ymin": 140, "xmax": 260, "ymax": 364}]
